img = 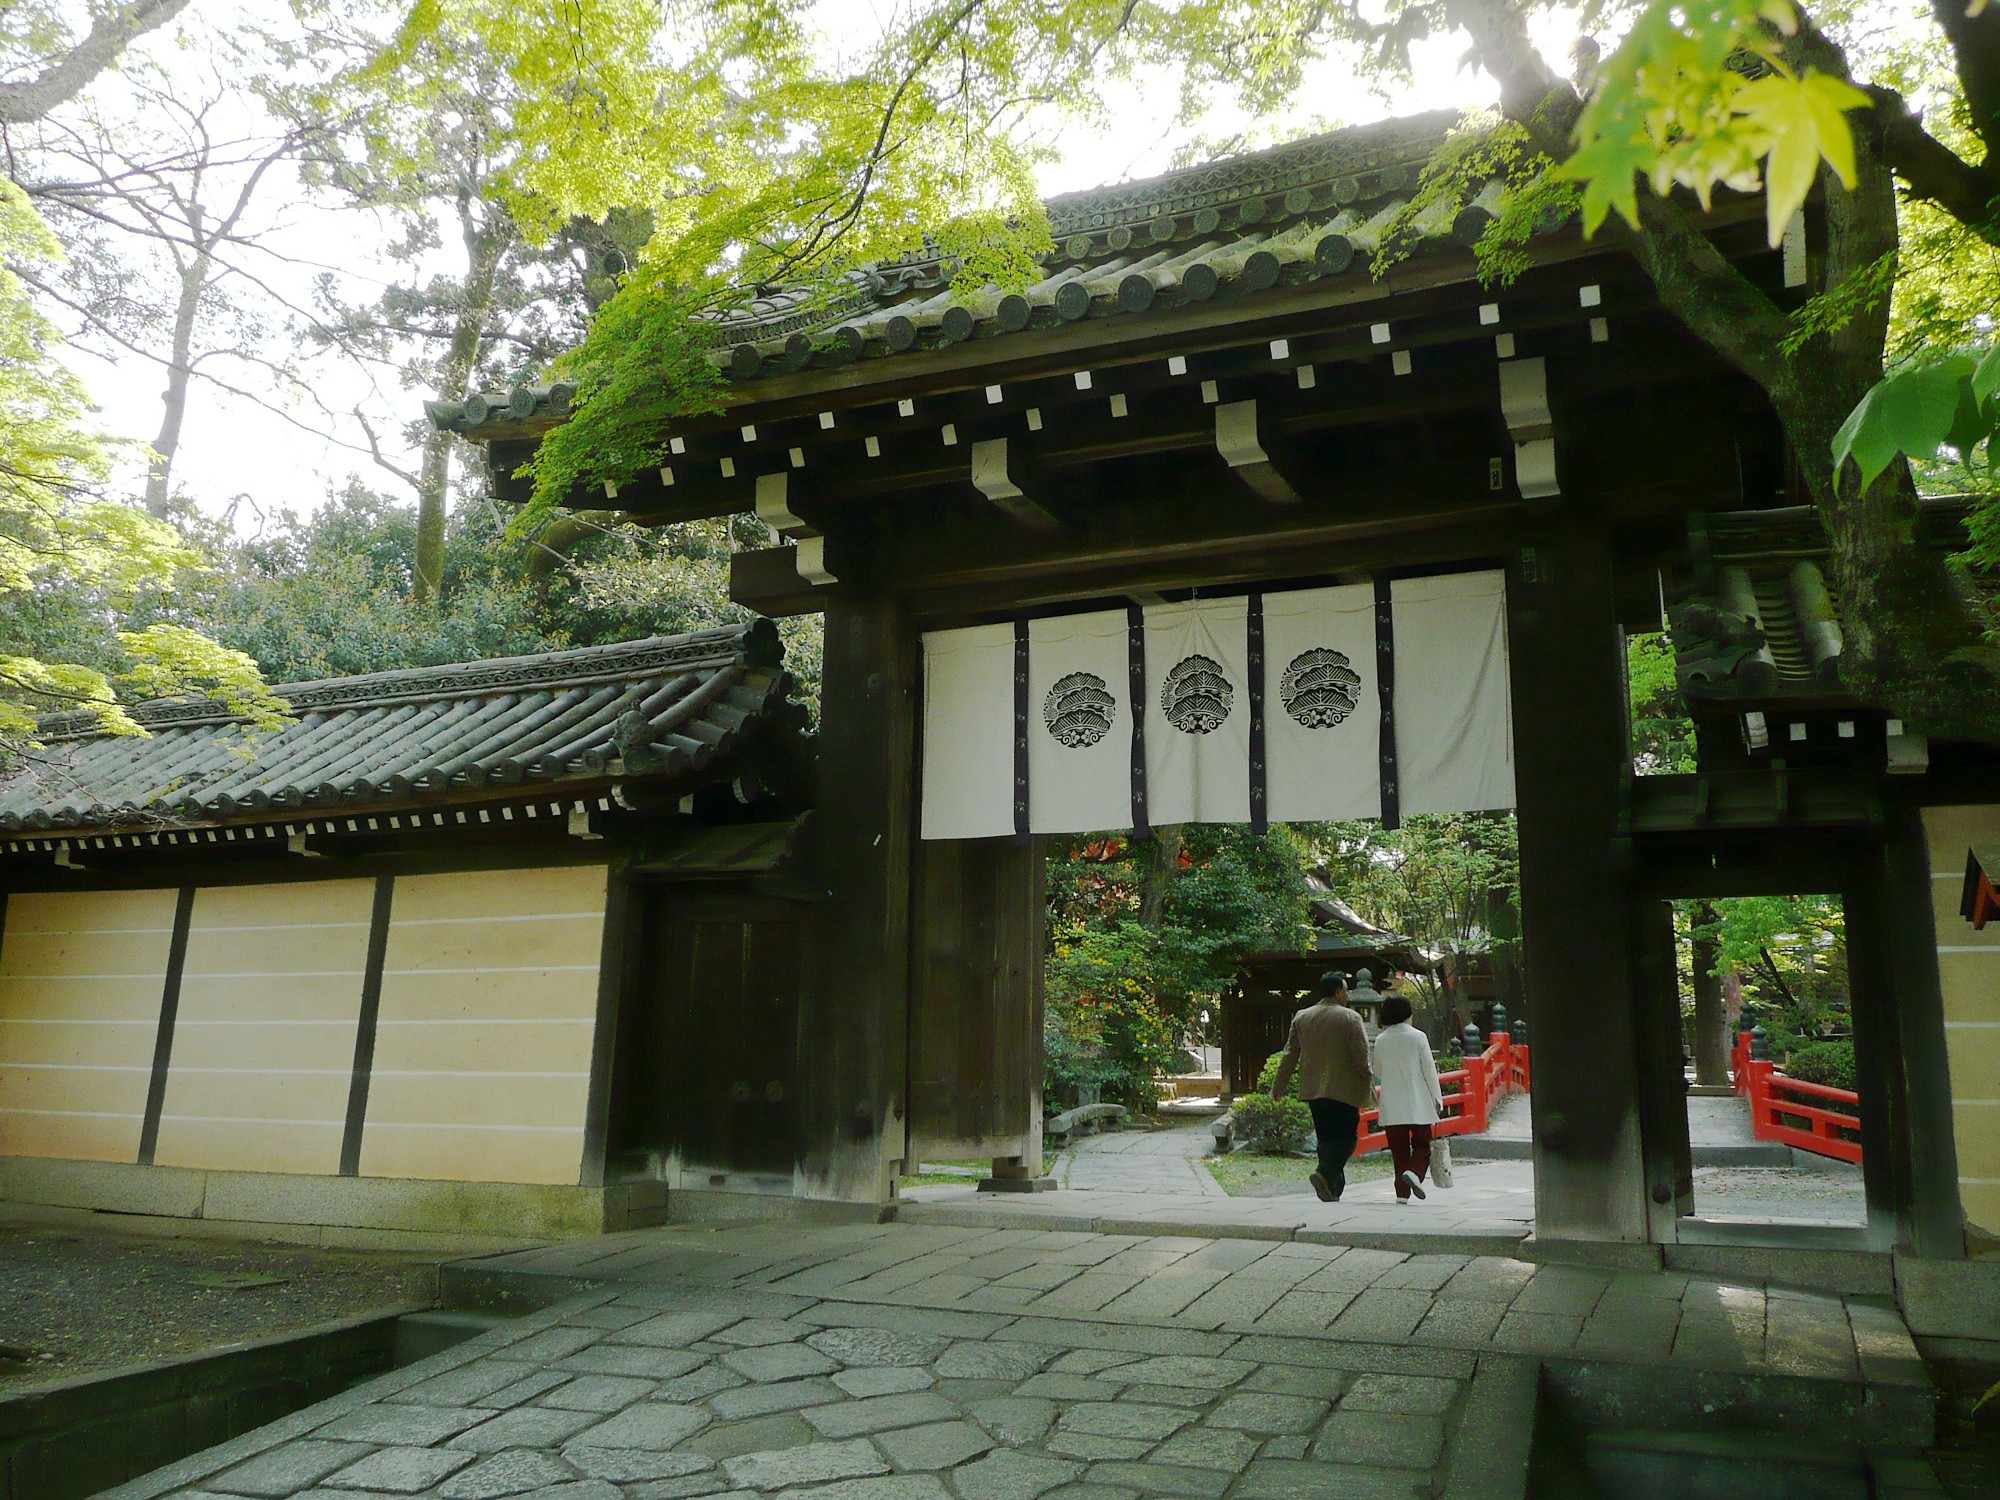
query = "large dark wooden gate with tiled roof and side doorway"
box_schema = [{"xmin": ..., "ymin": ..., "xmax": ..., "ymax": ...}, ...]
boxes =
[{"xmin": 434, "ymin": 116, "xmax": 1992, "ymax": 1256}]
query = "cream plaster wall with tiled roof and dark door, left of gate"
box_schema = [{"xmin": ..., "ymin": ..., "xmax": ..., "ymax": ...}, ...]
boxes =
[{"xmin": 0, "ymin": 620, "xmax": 812, "ymax": 1236}]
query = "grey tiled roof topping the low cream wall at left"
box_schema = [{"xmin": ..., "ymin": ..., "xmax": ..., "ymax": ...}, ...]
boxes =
[{"xmin": 0, "ymin": 620, "xmax": 788, "ymax": 840}]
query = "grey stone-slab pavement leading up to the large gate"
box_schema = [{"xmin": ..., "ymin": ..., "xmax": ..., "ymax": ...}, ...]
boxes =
[{"xmin": 110, "ymin": 1220, "xmax": 1932, "ymax": 1500}]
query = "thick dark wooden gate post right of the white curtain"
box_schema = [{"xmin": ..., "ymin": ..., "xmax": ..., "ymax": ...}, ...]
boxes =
[{"xmin": 1508, "ymin": 514, "xmax": 1646, "ymax": 1242}]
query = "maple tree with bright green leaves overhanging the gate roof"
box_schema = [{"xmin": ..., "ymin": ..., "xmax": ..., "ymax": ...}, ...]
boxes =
[{"xmin": 488, "ymin": 0, "xmax": 2000, "ymax": 740}]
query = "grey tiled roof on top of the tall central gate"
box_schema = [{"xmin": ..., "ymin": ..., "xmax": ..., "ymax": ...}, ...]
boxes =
[{"xmin": 428, "ymin": 110, "xmax": 1504, "ymax": 438}]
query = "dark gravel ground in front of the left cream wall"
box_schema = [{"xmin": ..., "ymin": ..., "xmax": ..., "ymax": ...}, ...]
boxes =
[{"xmin": 0, "ymin": 1222, "xmax": 430, "ymax": 1392}]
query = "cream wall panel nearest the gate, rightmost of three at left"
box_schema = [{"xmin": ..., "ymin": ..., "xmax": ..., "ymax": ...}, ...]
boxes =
[{"xmin": 360, "ymin": 864, "xmax": 606, "ymax": 1184}]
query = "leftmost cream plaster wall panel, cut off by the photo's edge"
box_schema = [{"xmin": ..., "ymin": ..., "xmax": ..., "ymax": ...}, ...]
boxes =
[{"xmin": 0, "ymin": 890, "xmax": 176, "ymax": 1162}]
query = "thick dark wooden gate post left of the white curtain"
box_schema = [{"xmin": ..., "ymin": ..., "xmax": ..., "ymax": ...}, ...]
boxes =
[{"xmin": 798, "ymin": 598, "xmax": 918, "ymax": 1202}]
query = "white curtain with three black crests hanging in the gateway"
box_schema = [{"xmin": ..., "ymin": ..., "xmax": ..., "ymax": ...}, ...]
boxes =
[{"xmin": 922, "ymin": 572, "xmax": 1514, "ymax": 838}]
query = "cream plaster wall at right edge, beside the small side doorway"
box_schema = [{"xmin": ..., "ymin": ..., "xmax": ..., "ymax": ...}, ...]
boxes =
[{"xmin": 1924, "ymin": 806, "xmax": 2000, "ymax": 1252}]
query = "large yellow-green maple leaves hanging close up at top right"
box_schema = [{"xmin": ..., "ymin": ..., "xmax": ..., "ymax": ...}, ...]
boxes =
[{"xmin": 1558, "ymin": 0, "xmax": 1870, "ymax": 246}]
